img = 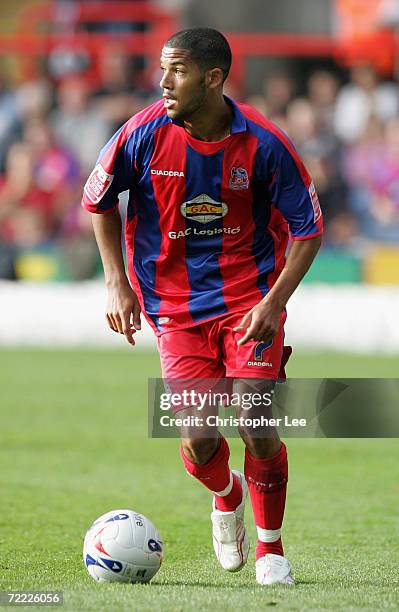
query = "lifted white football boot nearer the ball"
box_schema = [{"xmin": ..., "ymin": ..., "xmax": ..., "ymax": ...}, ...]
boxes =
[{"xmin": 211, "ymin": 470, "xmax": 249, "ymax": 572}]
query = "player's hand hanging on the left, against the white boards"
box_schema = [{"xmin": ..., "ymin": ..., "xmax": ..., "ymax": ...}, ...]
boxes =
[{"xmin": 106, "ymin": 281, "xmax": 141, "ymax": 346}]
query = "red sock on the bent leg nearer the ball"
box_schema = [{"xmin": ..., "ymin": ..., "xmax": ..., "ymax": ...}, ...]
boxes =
[{"xmin": 180, "ymin": 438, "xmax": 242, "ymax": 512}]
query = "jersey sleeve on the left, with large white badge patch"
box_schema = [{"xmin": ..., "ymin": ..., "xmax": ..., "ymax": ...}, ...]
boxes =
[{"xmin": 82, "ymin": 126, "xmax": 134, "ymax": 213}]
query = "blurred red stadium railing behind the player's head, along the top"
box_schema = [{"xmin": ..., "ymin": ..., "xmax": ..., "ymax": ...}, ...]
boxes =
[{"xmin": 0, "ymin": 1, "xmax": 399, "ymax": 92}]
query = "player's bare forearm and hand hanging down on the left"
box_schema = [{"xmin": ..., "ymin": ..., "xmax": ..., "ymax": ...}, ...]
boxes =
[{"xmin": 92, "ymin": 208, "xmax": 141, "ymax": 346}]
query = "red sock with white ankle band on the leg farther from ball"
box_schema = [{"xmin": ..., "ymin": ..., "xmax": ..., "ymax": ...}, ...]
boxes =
[{"xmin": 245, "ymin": 442, "xmax": 288, "ymax": 559}]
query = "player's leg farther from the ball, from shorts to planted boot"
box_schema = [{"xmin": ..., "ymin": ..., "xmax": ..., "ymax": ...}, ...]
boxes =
[{"xmin": 224, "ymin": 312, "xmax": 292, "ymax": 584}]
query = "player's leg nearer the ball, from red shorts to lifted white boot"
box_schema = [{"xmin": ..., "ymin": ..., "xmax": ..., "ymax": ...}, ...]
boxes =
[{"xmin": 159, "ymin": 325, "xmax": 249, "ymax": 571}]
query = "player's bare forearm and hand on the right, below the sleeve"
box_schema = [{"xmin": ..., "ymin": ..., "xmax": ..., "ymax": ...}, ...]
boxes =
[{"xmin": 235, "ymin": 236, "xmax": 322, "ymax": 344}]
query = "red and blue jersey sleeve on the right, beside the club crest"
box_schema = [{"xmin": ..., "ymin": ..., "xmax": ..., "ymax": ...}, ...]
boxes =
[{"xmin": 267, "ymin": 134, "xmax": 323, "ymax": 240}]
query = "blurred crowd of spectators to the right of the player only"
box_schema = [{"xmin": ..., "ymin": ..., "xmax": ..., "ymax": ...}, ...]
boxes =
[{"xmin": 249, "ymin": 65, "xmax": 399, "ymax": 253}]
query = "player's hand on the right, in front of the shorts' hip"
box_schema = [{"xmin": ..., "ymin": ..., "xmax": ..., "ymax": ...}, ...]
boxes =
[{"xmin": 233, "ymin": 300, "xmax": 281, "ymax": 346}]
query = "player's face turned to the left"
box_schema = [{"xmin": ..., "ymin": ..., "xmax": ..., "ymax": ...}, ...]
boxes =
[{"xmin": 160, "ymin": 47, "xmax": 207, "ymax": 119}]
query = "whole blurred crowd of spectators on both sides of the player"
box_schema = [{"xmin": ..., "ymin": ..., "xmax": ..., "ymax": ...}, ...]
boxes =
[{"xmin": 0, "ymin": 52, "xmax": 399, "ymax": 279}]
